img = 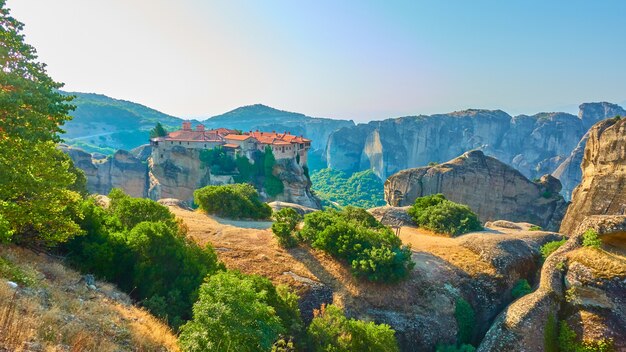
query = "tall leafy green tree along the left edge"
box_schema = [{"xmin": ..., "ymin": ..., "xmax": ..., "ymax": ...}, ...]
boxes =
[{"xmin": 0, "ymin": 0, "xmax": 81, "ymax": 247}]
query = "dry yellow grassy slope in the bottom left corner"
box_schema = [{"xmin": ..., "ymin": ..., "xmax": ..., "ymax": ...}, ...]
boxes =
[{"xmin": 0, "ymin": 246, "xmax": 178, "ymax": 352}]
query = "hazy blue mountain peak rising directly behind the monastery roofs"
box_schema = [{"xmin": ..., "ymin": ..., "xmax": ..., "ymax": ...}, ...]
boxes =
[{"xmin": 202, "ymin": 104, "xmax": 354, "ymax": 150}]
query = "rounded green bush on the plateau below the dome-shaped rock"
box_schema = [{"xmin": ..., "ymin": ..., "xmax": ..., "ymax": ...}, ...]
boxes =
[{"xmin": 409, "ymin": 194, "xmax": 482, "ymax": 236}]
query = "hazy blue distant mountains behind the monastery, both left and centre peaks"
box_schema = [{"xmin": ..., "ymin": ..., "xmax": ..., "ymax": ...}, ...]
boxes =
[{"xmin": 63, "ymin": 92, "xmax": 354, "ymax": 154}]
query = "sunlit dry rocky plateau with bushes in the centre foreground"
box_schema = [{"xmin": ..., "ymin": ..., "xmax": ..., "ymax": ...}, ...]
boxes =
[{"xmin": 170, "ymin": 206, "xmax": 559, "ymax": 351}]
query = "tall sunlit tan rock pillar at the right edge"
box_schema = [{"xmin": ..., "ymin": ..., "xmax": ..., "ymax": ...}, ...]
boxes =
[{"xmin": 561, "ymin": 119, "xmax": 626, "ymax": 233}]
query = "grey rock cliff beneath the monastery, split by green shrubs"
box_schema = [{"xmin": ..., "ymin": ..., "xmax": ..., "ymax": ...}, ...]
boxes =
[{"xmin": 61, "ymin": 146, "xmax": 321, "ymax": 209}]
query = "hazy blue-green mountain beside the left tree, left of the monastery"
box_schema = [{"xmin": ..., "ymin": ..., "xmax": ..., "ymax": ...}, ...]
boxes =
[{"xmin": 62, "ymin": 92, "xmax": 182, "ymax": 154}]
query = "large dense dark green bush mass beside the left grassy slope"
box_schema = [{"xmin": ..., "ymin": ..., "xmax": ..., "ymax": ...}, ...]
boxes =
[{"xmin": 61, "ymin": 191, "xmax": 224, "ymax": 327}]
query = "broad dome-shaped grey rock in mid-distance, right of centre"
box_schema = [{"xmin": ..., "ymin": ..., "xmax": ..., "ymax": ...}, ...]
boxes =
[{"xmin": 385, "ymin": 150, "xmax": 567, "ymax": 230}]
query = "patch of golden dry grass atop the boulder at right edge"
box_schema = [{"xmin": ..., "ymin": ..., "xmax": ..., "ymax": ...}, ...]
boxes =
[{"xmin": 568, "ymin": 247, "xmax": 626, "ymax": 280}]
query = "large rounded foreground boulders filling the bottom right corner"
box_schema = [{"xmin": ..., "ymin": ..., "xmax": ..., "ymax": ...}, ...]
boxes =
[{"xmin": 478, "ymin": 216, "xmax": 626, "ymax": 352}]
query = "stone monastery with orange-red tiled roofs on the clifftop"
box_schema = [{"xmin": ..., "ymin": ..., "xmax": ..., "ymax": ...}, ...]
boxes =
[{"xmin": 150, "ymin": 121, "xmax": 311, "ymax": 166}]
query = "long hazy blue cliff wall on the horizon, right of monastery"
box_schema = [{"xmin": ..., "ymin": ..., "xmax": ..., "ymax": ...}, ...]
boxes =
[{"xmin": 325, "ymin": 103, "xmax": 626, "ymax": 191}]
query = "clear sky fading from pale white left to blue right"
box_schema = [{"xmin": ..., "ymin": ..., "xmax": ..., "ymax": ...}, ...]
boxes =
[{"xmin": 8, "ymin": 0, "xmax": 626, "ymax": 121}]
